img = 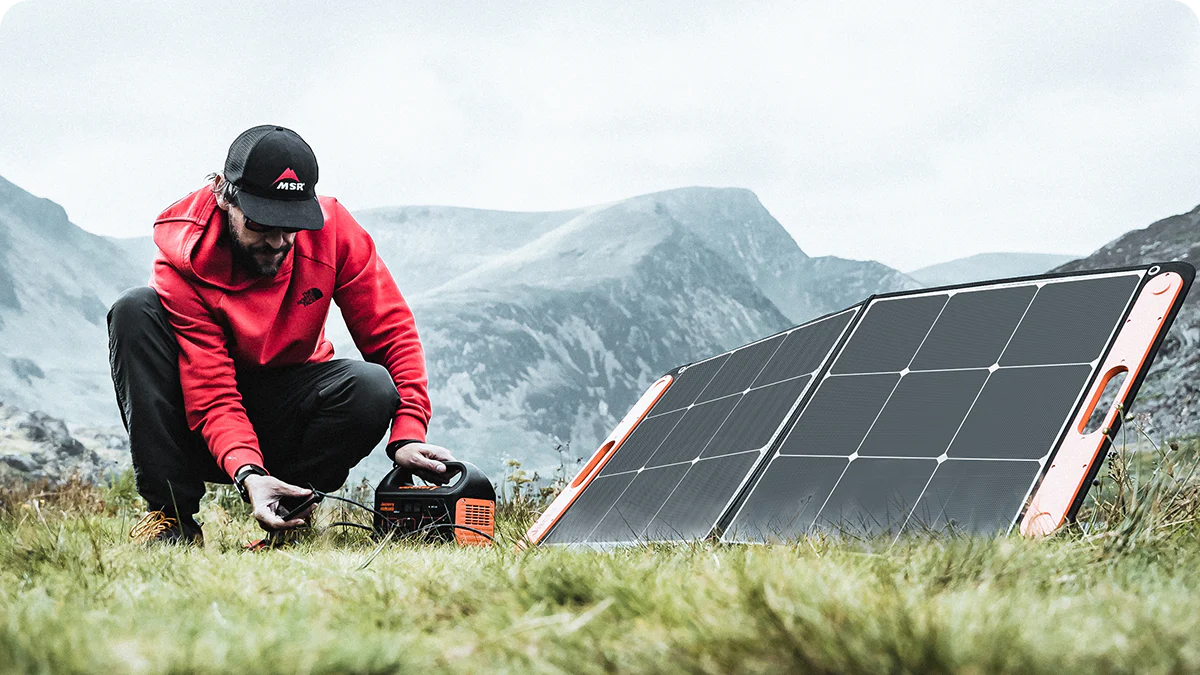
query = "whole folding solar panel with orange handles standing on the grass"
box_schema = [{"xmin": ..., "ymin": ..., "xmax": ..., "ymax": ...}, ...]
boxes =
[{"xmin": 527, "ymin": 263, "xmax": 1195, "ymax": 545}]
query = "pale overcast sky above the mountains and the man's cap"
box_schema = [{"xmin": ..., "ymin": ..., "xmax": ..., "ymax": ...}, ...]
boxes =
[{"xmin": 0, "ymin": 0, "xmax": 1200, "ymax": 270}]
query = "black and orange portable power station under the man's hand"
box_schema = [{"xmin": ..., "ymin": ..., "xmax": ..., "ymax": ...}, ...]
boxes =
[{"xmin": 374, "ymin": 461, "xmax": 496, "ymax": 546}]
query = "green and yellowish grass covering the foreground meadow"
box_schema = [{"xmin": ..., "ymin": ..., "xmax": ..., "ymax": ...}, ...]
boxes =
[{"xmin": 0, "ymin": 437, "xmax": 1200, "ymax": 675}]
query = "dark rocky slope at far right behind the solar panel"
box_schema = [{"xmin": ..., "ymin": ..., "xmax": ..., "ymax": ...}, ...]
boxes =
[{"xmin": 1052, "ymin": 201, "xmax": 1200, "ymax": 438}]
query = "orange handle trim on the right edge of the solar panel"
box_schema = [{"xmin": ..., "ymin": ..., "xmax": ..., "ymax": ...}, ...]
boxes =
[{"xmin": 1021, "ymin": 271, "xmax": 1183, "ymax": 537}]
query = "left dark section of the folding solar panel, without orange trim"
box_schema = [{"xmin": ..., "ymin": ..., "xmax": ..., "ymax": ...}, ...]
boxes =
[{"xmin": 545, "ymin": 307, "xmax": 858, "ymax": 544}]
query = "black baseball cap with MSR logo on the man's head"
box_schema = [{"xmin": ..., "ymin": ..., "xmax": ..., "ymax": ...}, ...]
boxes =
[{"xmin": 224, "ymin": 124, "xmax": 325, "ymax": 229}]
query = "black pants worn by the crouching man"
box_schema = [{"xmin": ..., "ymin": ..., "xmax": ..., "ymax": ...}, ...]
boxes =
[{"xmin": 108, "ymin": 287, "xmax": 400, "ymax": 524}]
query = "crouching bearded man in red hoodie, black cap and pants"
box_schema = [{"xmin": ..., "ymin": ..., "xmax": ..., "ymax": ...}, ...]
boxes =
[{"xmin": 108, "ymin": 125, "xmax": 452, "ymax": 542}]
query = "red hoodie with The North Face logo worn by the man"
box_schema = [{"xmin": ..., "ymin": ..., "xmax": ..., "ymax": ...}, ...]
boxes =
[{"xmin": 150, "ymin": 187, "xmax": 430, "ymax": 477}]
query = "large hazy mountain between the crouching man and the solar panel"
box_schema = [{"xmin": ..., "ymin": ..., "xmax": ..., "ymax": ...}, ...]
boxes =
[{"xmin": 330, "ymin": 187, "xmax": 918, "ymax": 471}]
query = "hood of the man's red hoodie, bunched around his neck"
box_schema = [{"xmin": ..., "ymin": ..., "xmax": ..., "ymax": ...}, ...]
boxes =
[{"xmin": 154, "ymin": 186, "xmax": 295, "ymax": 291}]
